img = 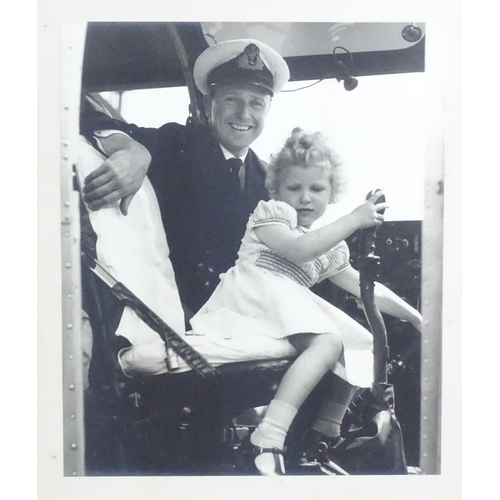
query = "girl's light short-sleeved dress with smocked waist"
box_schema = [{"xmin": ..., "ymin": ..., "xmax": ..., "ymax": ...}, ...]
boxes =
[{"xmin": 191, "ymin": 200, "xmax": 373, "ymax": 387}]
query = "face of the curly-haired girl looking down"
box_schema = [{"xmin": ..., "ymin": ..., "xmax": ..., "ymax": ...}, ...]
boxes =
[{"xmin": 276, "ymin": 165, "xmax": 332, "ymax": 228}]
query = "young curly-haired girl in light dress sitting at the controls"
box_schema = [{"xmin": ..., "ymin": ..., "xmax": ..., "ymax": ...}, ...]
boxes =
[{"xmin": 191, "ymin": 129, "xmax": 421, "ymax": 475}]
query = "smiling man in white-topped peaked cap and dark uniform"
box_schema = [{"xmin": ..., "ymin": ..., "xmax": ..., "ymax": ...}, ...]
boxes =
[{"xmin": 81, "ymin": 39, "xmax": 290, "ymax": 312}]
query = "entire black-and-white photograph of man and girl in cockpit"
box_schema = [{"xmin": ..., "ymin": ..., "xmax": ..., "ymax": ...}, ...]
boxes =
[{"xmin": 37, "ymin": 1, "xmax": 462, "ymax": 498}]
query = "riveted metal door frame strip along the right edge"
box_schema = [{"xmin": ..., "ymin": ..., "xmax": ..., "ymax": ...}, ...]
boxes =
[{"xmin": 420, "ymin": 26, "xmax": 444, "ymax": 474}]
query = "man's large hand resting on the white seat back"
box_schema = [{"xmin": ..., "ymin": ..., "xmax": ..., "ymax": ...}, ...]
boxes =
[{"xmin": 83, "ymin": 134, "xmax": 151, "ymax": 215}]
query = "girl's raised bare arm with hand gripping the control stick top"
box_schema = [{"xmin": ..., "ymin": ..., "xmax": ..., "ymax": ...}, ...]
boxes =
[{"xmin": 255, "ymin": 194, "xmax": 387, "ymax": 262}]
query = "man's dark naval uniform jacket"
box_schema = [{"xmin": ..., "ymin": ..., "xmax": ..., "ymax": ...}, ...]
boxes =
[{"xmin": 82, "ymin": 115, "xmax": 268, "ymax": 312}]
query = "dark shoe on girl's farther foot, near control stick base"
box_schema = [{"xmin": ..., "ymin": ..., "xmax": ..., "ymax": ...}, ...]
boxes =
[{"xmin": 301, "ymin": 429, "xmax": 349, "ymax": 476}]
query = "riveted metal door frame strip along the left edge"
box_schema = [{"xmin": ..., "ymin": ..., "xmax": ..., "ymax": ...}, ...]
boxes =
[{"xmin": 60, "ymin": 24, "xmax": 85, "ymax": 476}]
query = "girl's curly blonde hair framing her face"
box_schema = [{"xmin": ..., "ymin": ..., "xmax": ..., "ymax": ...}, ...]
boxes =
[{"xmin": 266, "ymin": 127, "xmax": 345, "ymax": 203}]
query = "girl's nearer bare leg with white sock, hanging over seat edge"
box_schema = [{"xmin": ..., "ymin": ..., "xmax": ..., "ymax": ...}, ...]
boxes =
[{"xmin": 250, "ymin": 334, "xmax": 342, "ymax": 471}]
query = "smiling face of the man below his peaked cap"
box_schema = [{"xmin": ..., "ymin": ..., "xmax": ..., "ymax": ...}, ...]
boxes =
[{"xmin": 205, "ymin": 84, "xmax": 271, "ymax": 156}]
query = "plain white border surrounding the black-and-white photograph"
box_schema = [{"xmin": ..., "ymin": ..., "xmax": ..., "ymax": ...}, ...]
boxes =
[{"xmin": 20, "ymin": 0, "xmax": 484, "ymax": 500}]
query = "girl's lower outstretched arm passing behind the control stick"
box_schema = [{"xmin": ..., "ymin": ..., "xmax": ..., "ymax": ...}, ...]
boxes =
[{"xmin": 329, "ymin": 267, "xmax": 422, "ymax": 332}]
